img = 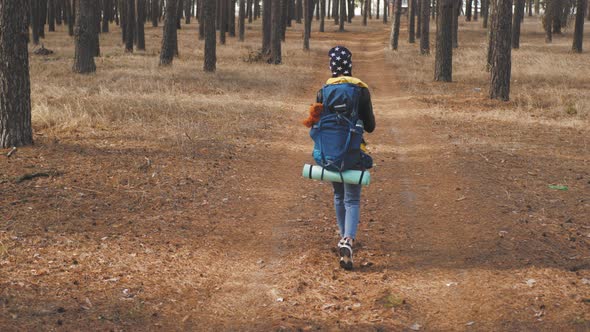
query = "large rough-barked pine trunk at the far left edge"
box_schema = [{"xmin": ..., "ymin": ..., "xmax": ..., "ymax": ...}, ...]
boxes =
[{"xmin": 0, "ymin": 0, "xmax": 33, "ymax": 148}]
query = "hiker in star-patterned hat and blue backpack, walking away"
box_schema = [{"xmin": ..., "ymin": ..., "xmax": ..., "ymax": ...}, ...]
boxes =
[{"xmin": 308, "ymin": 46, "xmax": 375, "ymax": 270}]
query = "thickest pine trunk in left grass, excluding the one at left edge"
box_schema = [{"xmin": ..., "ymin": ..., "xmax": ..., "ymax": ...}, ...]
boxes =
[{"xmin": 72, "ymin": 0, "xmax": 98, "ymax": 74}]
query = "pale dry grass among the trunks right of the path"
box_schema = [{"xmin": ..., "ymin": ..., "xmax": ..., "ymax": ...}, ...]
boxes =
[{"xmin": 391, "ymin": 18, "xmax": 590, "ymax": 126}]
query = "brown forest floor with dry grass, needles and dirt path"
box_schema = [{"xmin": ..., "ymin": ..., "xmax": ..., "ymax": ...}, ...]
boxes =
[{"xmin": 0, "ymin": 14, "xmax": 590, "ymax": 331}]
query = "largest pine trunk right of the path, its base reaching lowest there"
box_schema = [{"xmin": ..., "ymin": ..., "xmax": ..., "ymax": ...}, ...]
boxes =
[{"xmin": 490, "ymin": 0, "xmax": 512, "ymax": 101}]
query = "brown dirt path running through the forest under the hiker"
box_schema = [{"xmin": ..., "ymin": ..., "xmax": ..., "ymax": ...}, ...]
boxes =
[{"xmin": 193, "ymin": 26, "xmax": 583, "ymax": 330}]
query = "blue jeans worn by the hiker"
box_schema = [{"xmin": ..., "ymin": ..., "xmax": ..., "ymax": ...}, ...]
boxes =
[{"xmin": 332, "ymin": 182, "xmax": 362, "ymax": 239}]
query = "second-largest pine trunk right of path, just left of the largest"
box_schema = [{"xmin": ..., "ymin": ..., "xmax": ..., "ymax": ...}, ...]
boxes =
[{"xmin": 434, "ymin": 0, "xmax": 456, "ymax": 82}]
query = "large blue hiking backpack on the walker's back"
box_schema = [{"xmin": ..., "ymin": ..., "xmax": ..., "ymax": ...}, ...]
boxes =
[{"xmin": 309, "ymin": 83, "xmax": 370, "ymax": 172}]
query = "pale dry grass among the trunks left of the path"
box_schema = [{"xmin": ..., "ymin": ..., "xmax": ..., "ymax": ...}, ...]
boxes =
[{"xmin": 31, "ymin": 24, "xmax": 320, "ymax": 142}]
